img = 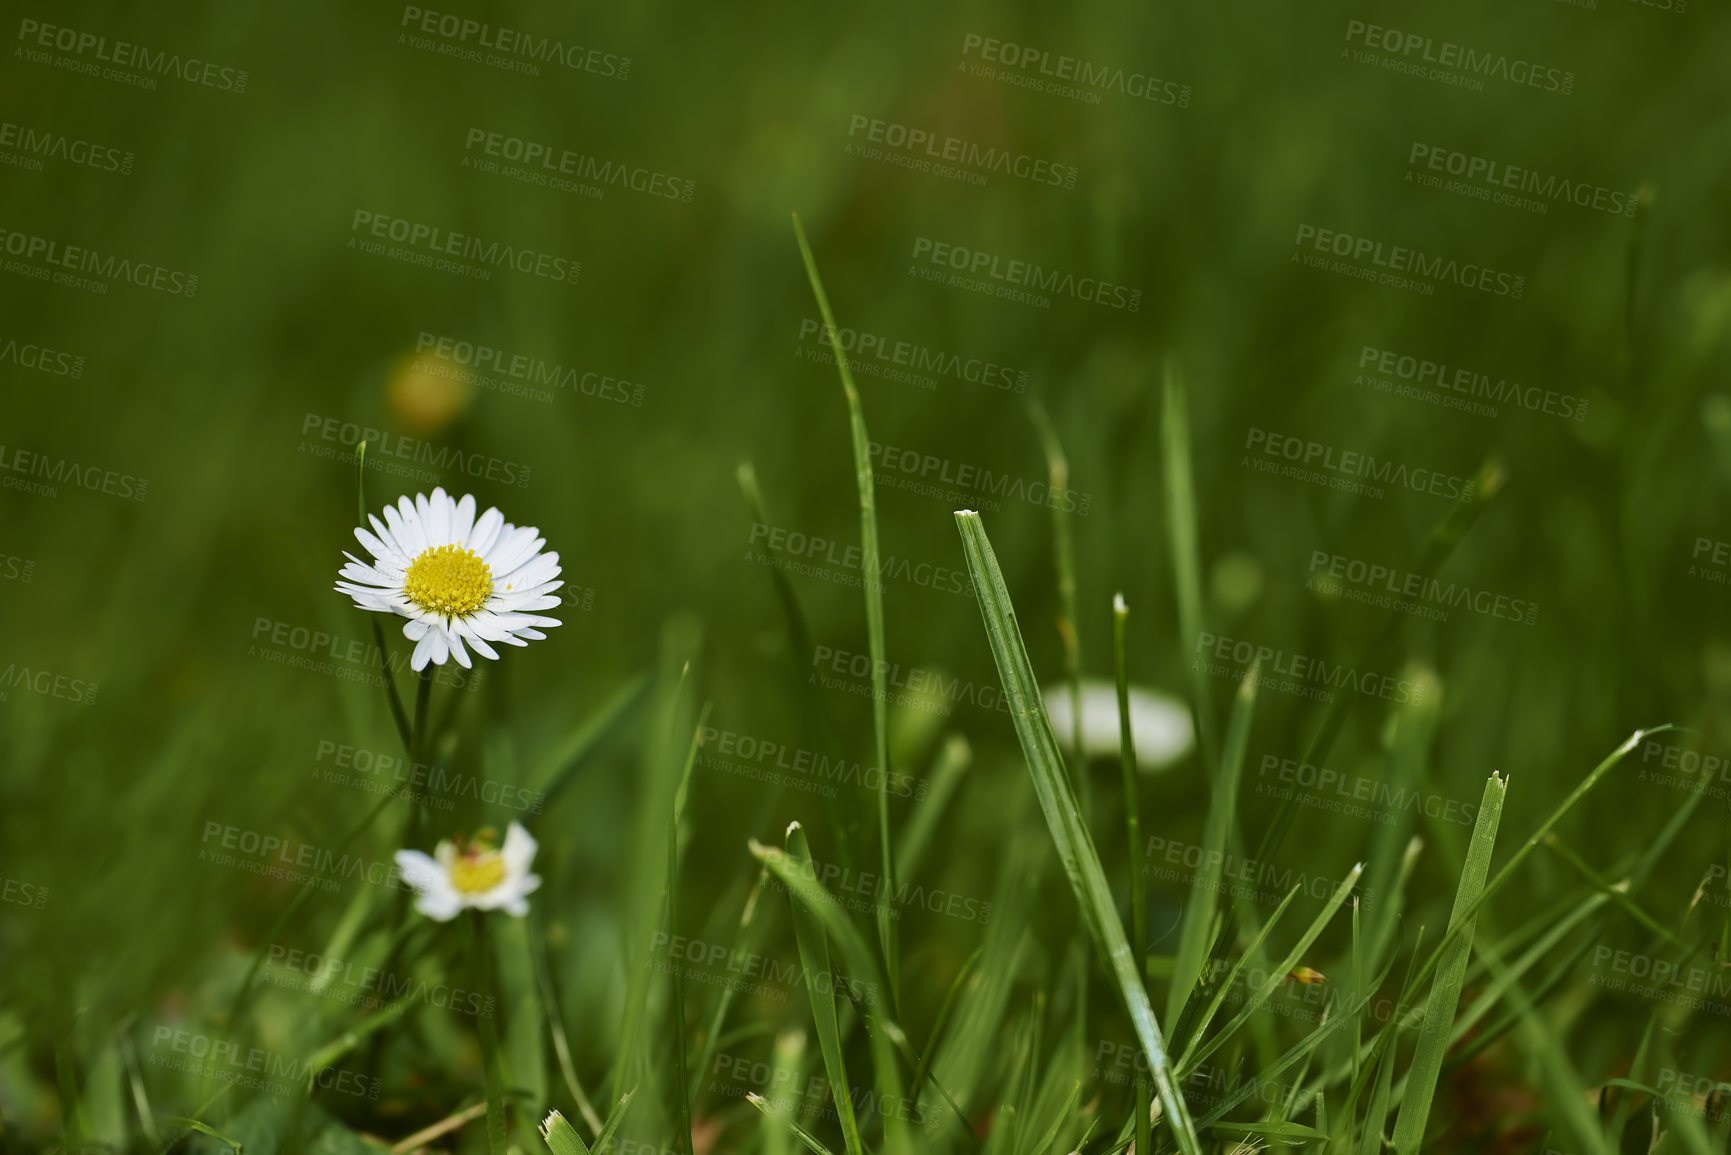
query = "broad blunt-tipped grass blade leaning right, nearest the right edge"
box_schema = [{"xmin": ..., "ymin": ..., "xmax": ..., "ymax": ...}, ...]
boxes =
[{"xmin": 1395, "ymin": 774, "xmax": 1508, "ymax": 1155}]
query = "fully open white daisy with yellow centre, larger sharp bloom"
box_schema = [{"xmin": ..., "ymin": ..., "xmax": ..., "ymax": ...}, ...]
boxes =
[{"xmin": 336, "ymin": 488, "xmax": 564, "ymax": 670}]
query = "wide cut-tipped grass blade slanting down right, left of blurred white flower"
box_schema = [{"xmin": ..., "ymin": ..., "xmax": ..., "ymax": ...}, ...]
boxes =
[{"xmin": 956, "ymin": 511, "xmax": 1201, "ymax": 1155}]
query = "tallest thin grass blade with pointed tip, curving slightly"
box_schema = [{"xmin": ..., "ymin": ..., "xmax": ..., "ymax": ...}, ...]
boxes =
[{"xmin": 793, "ymin": 213, "xmax": 902, "ymax": 1006}]
